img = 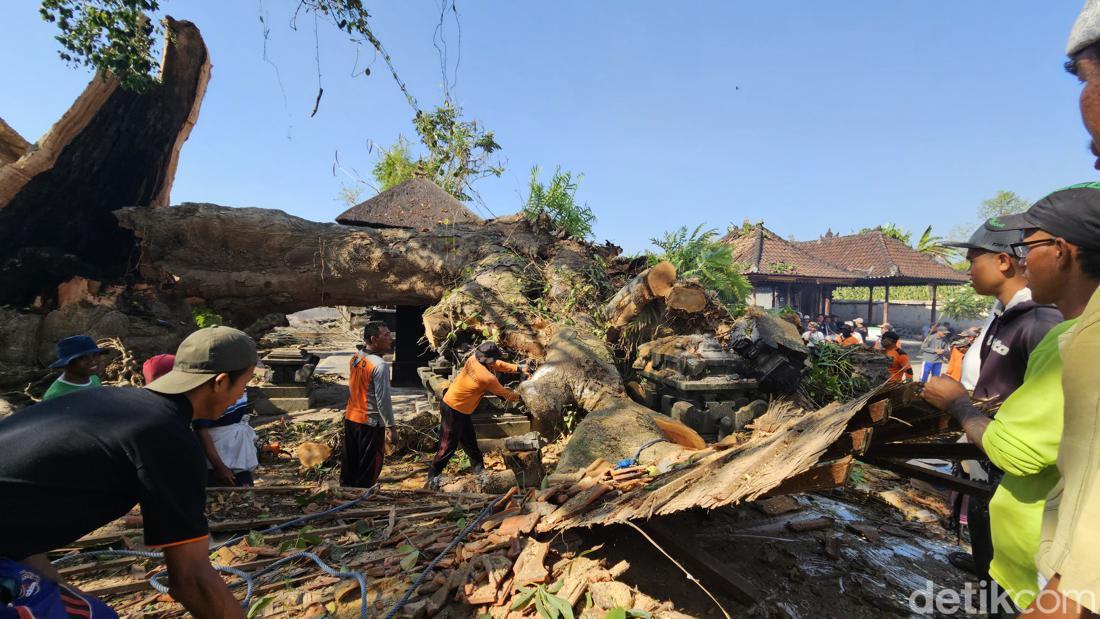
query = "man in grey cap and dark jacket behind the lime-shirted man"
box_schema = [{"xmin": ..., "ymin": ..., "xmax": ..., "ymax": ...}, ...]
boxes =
[{"xmin": 946, "ymin": 222, "xmax": 1062, "ymax": 597}]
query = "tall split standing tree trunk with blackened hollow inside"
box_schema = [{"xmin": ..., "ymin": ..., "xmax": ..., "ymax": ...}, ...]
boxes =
[{"xmin": 0, "ymin": 18, "xmax": 210, "ymax": 306}]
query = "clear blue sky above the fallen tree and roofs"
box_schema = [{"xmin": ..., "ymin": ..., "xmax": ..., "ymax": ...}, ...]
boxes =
[{"xmin": 0, "ymin": 0, "xmax": 1096, "ymax": 252}]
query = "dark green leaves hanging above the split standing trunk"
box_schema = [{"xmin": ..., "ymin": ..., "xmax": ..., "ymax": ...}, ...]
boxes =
[{"xmin": 39, "ymin": 0, "xmax": 161, "ymax": 91}]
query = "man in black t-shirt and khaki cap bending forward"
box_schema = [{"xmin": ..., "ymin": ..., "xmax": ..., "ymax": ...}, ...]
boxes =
[{"xmin": 0, "ymin": 327, "xmax": 256, "ymax": 618}]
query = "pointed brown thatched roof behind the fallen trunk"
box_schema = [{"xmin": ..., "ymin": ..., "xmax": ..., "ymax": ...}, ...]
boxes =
[{"xmin": 337, "ymin": 178, "xmax": 482, "ymax": 229}]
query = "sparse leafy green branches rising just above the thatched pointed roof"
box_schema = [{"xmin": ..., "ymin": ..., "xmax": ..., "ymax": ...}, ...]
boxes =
[{"xmin": 372, "ymin": 100, "xmax": 504, "ymax": 201}]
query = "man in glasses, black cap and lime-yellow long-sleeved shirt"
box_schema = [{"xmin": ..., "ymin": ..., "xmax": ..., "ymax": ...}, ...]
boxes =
[{"xmin": 924, "ymin": 184, "xmax": 1100, "ymax": 610}]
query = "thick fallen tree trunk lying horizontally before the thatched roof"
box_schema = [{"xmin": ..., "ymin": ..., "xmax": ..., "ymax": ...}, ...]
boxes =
[{"xmin": 116, "ymin": 203, "xmax": 554, "ymax": 329}]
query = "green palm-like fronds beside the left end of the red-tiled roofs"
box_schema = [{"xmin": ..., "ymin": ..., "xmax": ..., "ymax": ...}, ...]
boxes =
[{"xmin": 649, "ymin": 224, "xmax": 752, "ymax": 309}]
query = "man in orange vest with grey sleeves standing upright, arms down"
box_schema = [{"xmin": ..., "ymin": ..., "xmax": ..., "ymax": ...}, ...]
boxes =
[{"xmin": 340, "ymin": 320, "xmax": 397, "ymax": 488}]
